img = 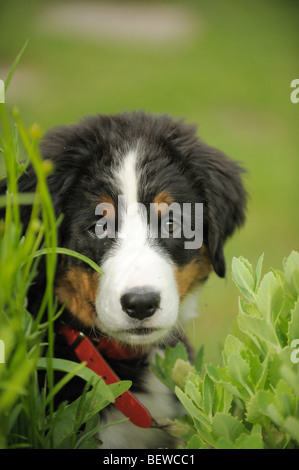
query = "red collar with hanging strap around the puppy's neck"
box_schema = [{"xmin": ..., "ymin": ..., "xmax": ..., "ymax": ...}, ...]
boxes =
[{"xmin": 60, "ymin": 325, "xmax": 152, "ymax": 428}]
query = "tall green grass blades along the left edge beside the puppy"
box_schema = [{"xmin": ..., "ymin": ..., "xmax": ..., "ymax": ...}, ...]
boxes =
[{"xmin": 0, "ymin": 44, "xmax": 131, "ymax": 449}]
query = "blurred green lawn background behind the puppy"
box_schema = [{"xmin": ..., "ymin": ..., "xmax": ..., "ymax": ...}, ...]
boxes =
[{"xmin": 0, "ymin": 0, "xmax": 299, "ymax": 363}]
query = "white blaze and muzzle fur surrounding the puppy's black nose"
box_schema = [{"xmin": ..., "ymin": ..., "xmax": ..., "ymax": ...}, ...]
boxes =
[{"xmin": 96, "ymin": 145, "xmax": 179, "ymax": 341}]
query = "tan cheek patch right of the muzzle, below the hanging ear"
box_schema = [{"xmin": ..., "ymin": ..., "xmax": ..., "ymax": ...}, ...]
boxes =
[{"xmin": 175, "ymin": 247, "xmax": 212, "ymax": 299}]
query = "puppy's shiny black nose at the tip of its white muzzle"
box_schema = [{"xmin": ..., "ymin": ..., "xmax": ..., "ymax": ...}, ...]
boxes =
[{"xmin": 120, "ymin": 288, "xmax": 160, "ymax": 320}]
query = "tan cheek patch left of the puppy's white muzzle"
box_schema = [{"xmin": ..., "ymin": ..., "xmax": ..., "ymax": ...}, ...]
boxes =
[{"xmin": 55, "ymin": 268, "xmax": 99, "ymax": 327}]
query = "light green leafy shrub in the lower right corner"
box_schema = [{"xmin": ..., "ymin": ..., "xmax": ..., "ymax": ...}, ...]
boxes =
[{"xmin": 153, "ymin": 251, "xmax": 299, "ymax": 449}]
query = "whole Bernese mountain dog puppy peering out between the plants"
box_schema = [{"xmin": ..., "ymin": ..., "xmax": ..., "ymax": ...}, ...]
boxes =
[{"xmin": 2, "ymin": 112, "xmax": 246, "ymax": 449}]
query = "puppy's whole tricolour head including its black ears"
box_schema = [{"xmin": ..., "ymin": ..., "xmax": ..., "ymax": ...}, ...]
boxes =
[{"xmin": 16, "ymin": 113, "xmax": 245, "ymax": 345}]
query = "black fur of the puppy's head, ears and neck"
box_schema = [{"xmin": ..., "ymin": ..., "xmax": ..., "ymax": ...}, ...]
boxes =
[{"xmin": 0, "ymin": 112, "xmax": 246, "ymax": 446}]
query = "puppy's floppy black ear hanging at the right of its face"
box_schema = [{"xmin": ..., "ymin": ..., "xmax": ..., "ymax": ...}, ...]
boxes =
[{"xmin": 202, "ymin": 146, "xmax": 246, "ymax": 277}]
